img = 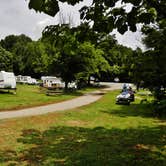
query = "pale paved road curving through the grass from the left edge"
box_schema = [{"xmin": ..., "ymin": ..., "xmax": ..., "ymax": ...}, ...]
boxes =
[{"xmin": 0, "ymin": 83, "xmax": 122, "ymax": 119}]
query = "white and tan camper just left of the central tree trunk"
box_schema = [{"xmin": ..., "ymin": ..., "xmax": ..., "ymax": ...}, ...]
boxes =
[{"xmin": 41, "ymin": 76, "xmax": 65, "ymax": 89}]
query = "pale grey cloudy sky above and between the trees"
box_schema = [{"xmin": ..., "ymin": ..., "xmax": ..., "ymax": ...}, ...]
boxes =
[{"xmin": 0, "ymin": 0, "xmax": 143, "ymax": 49}]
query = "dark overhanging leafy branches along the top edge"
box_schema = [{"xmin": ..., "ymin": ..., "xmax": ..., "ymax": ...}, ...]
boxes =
[{"xmin": 29, "ymin": 0, "xmax": 166, "ymax": 34}]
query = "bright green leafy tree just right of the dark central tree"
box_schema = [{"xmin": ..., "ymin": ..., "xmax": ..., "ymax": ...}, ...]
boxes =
[{"xmin": 77, "ymin": 42, "xmax": 110, "ymax": 84}]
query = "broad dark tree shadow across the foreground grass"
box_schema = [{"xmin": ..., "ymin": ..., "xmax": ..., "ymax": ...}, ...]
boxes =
[{"xmin": 0, "ymin": 126, "xmax": 166, "ymax": 166}]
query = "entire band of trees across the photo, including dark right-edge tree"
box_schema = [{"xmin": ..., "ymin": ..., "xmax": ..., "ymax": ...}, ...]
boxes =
[{"xmin": 0, "ymin": 21, "xmax": 166, "ymax": 112}]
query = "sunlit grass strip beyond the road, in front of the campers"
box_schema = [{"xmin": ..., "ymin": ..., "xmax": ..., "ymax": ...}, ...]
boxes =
[{"xmin": 0, "ymin": 85, "xmax": 99, "ymax": 111}]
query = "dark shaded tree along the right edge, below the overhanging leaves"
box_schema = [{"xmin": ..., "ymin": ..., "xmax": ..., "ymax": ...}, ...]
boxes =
[{"xmin": 135, "ymin": 20, "xmax": 166, "ymax": 100}]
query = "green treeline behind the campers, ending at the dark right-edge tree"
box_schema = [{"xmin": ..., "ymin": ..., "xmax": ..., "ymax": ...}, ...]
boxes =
[{"xmin": 0, "ymin": 24, "xmax": 135, "ymax": 84}]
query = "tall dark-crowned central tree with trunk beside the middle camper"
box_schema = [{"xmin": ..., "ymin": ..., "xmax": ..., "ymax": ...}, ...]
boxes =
[{"xmin": 42, "ymin": 24, "xmax": 79, "ymax": 89}]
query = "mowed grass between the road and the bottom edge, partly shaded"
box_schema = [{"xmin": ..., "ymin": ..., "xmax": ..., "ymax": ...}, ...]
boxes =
[{"xmin": 0, "ymin": 91, "xmax": 166, "ymax": 166}]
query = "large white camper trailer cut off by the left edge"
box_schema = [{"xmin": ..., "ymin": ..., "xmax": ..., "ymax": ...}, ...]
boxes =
[{"xmin": 0, "ymin": 71, "xmax": 16, "ymax": 89}]
